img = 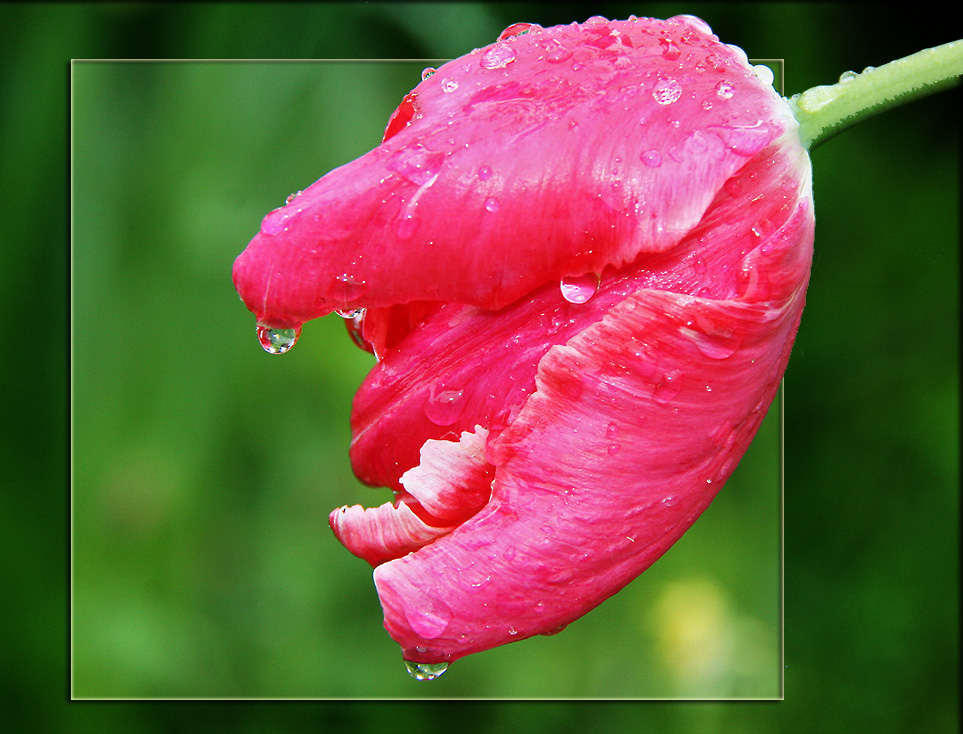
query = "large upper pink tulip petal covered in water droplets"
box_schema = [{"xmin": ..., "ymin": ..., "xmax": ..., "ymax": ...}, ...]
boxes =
[{"xmin": 234, "ymin": 19, "xmax": 795, "ymax": 328}]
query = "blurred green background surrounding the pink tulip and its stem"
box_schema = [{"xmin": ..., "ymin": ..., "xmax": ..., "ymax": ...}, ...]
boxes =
[{"xmin": 0, "ymin": 3, "xmax": 960, "ymax": 732}]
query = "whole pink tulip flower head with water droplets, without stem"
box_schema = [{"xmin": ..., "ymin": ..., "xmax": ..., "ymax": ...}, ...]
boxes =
[{"xmin": 234, "ymin": 16, "xmax": 814, "ymax": 676}]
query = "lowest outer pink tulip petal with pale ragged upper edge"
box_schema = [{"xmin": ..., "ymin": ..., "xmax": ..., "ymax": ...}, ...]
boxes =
[{"xmin": 375, "ymin": 239, "xmax": 803, "ymax": 662}]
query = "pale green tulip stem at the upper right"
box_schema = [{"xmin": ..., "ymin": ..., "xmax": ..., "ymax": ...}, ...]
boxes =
[{"xmin": 789, "ymin": 40, "xmax": 963, "ymax": 150}]
